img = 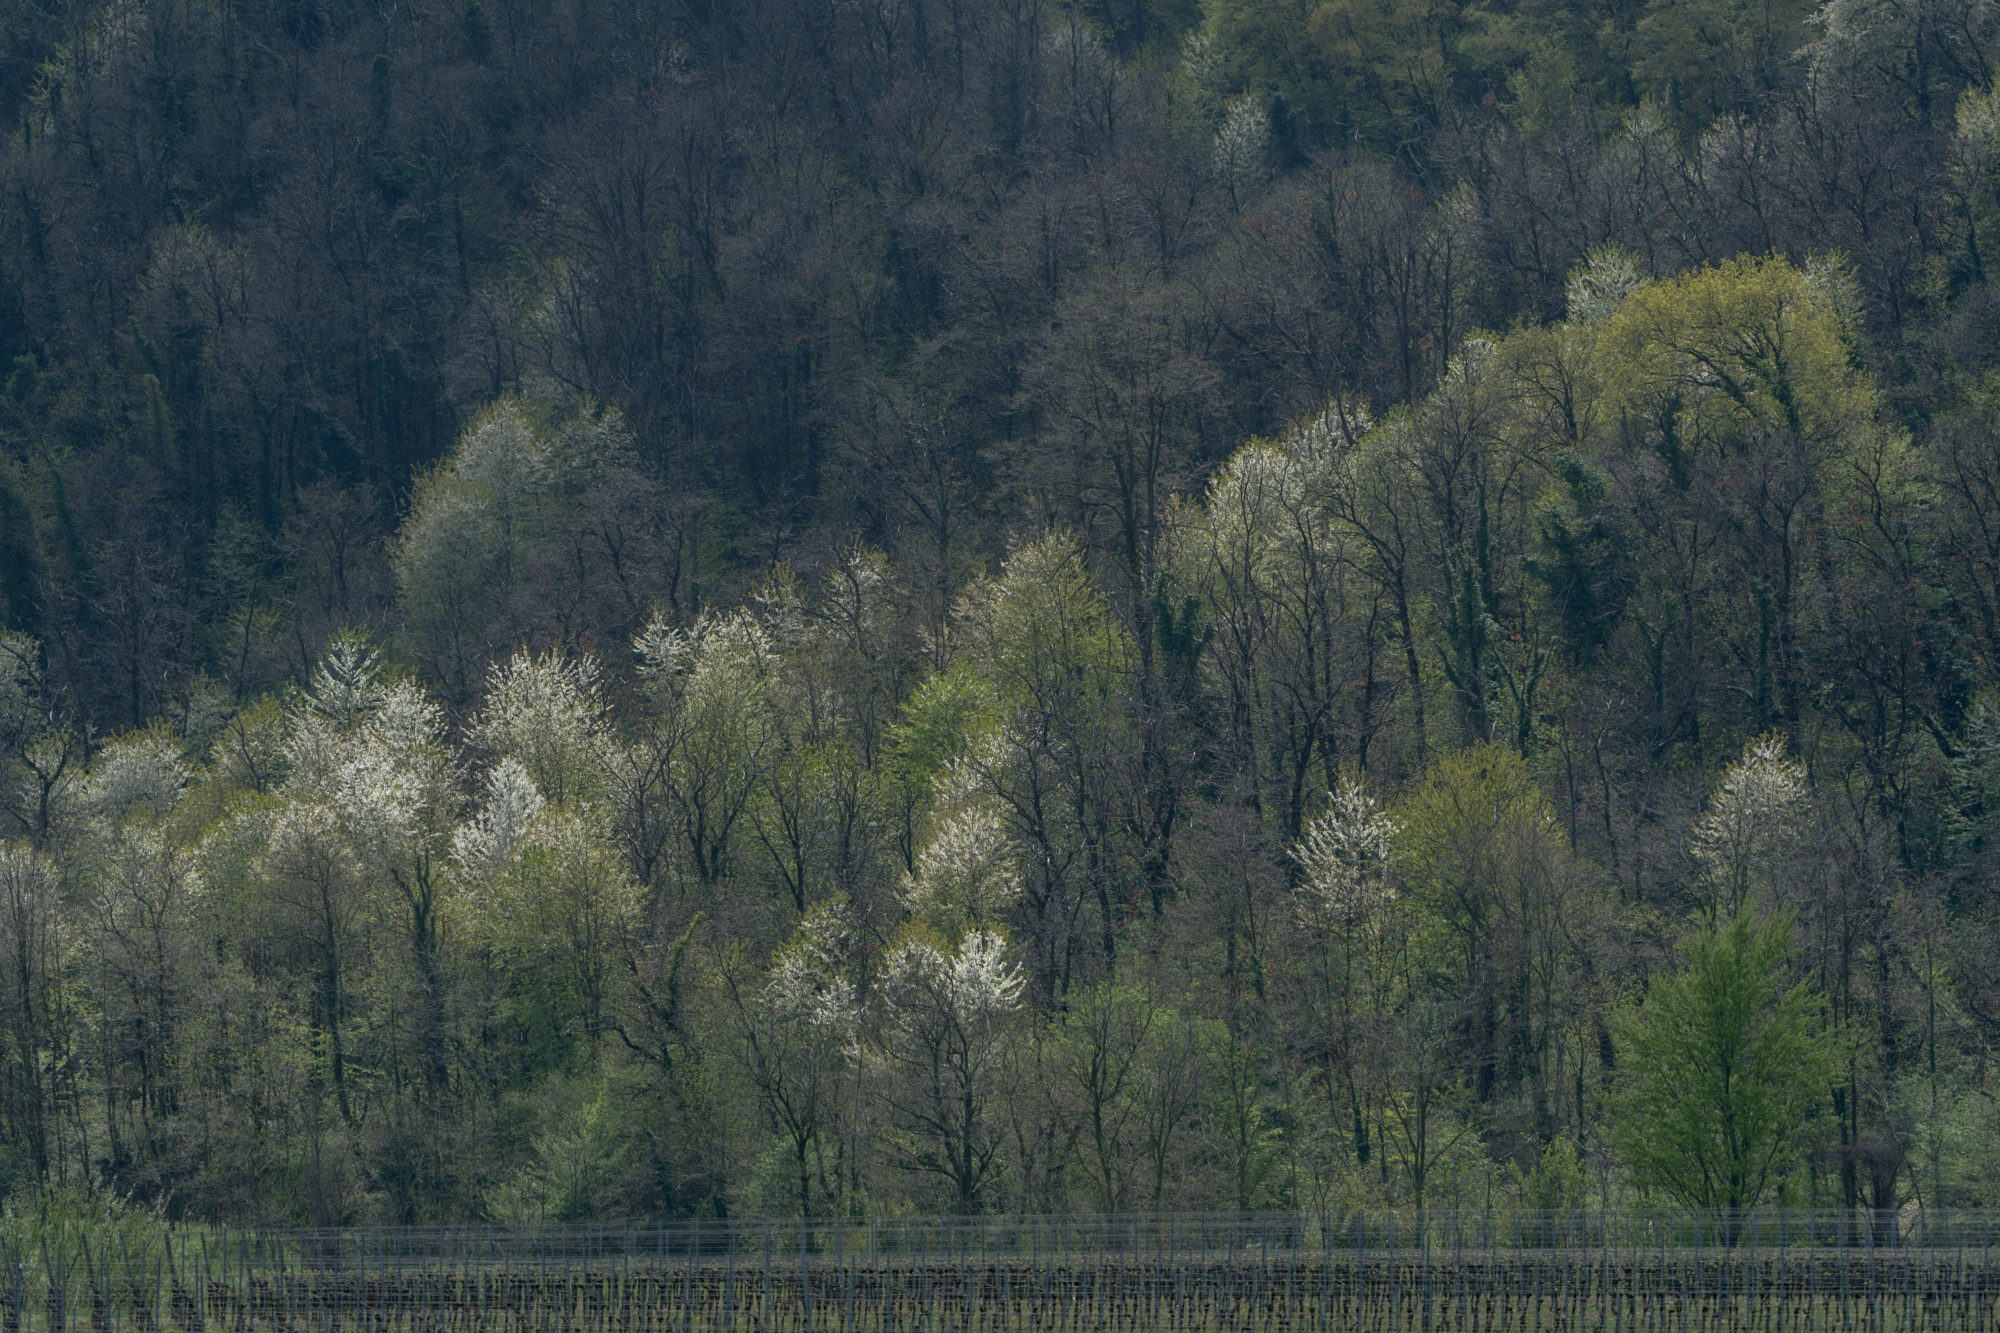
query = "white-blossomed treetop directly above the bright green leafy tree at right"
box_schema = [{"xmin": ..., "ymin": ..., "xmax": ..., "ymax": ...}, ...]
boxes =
[{"xmin": 1690, "ymin": 735, "xmax": 1812, "ymax": 921}]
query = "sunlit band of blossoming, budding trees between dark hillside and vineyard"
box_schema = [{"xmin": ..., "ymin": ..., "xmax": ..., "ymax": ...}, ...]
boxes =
[{"xmin": 0, "ymin": 244, "xmax": 2000, "ymax": 1223}]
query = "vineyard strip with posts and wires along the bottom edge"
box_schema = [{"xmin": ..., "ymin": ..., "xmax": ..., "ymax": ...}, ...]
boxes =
[{"xmin": 11, "ymin": 1213, "xmax": 2000, "ymax": 1333}]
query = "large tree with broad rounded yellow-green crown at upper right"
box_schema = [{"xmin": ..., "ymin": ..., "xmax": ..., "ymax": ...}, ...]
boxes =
[{"xmin": 1594, "ymin": 256, "xmax": 1884, "ymax": 741}]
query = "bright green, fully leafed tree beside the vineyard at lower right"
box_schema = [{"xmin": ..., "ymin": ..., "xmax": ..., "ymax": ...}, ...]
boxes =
[{"xmin": 1612, "ymin": 911, "xmax": 1840, "ymax": 1215}]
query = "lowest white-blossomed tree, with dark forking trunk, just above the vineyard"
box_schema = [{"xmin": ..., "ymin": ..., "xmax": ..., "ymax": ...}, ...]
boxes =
[{"xmin": 876, "ymin": 929, "xmax": 1022, "ymax": 1213}]
